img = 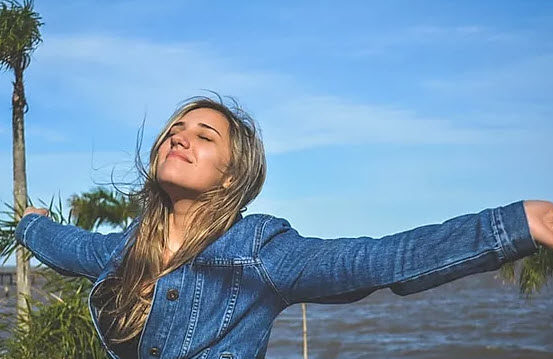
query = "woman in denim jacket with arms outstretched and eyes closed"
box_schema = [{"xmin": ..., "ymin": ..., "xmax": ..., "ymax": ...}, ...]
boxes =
[{"xmin": 16, "ymin": 98, "xmax": 553, "ymax": 359}]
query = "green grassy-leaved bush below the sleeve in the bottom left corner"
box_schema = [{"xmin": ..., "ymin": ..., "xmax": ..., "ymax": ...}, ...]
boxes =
[{"xmin": 0, "ymin": 269, "xmax": 108, "ymax": 359}]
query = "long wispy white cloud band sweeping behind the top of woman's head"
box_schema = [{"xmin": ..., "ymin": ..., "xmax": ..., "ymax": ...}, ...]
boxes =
[{"xmin": 23, "ymin": 34, "xmax": 536, "ymax": 153}]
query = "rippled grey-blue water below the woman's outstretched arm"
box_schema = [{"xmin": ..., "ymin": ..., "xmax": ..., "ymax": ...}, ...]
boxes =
[{"xmin": 0, "ymin": 272, "xmax": 553, "ymax": 359}]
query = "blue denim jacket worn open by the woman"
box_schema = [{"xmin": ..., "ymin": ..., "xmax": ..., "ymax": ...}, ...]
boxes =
[{"xmin": 16, "ymin": 201, "xmax": 537, "ymax": 359}]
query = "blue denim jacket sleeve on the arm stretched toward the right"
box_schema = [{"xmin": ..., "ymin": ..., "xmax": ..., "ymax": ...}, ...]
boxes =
[{"xmin": 259, "ymin": 201, "xmax": 538, "ymax": 305}]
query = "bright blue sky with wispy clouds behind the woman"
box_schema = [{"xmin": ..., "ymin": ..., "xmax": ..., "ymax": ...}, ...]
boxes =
[{"xmin": 0, "ymin": 0, "xmax": 553, "ymax": 266}]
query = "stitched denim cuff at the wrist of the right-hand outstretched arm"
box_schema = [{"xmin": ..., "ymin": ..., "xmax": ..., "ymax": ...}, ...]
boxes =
[{"xmin": 492, "ymin": 201, "xmax": 538, "ymax": 262}]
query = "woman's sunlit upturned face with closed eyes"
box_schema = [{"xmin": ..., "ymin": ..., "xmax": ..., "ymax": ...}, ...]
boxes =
[{"xmin": 157, "ymin": 108, "xmax": 230, "ymax": 201}]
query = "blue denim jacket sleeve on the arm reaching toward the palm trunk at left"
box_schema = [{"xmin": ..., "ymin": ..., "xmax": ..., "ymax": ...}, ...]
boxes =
[{"xmin": 15, "ymin": 213, "xmax": 137, "ymax": 280}]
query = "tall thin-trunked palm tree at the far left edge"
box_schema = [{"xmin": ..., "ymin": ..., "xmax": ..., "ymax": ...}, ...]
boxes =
[{"xmin": 0, "ymin": 0, "xmax": 43, "ymax": 324}]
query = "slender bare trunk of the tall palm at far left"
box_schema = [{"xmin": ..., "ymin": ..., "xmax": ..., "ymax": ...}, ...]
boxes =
[{"xmin": 12, "ymin": 64, "xmax": 31, "ymax": 324}]
